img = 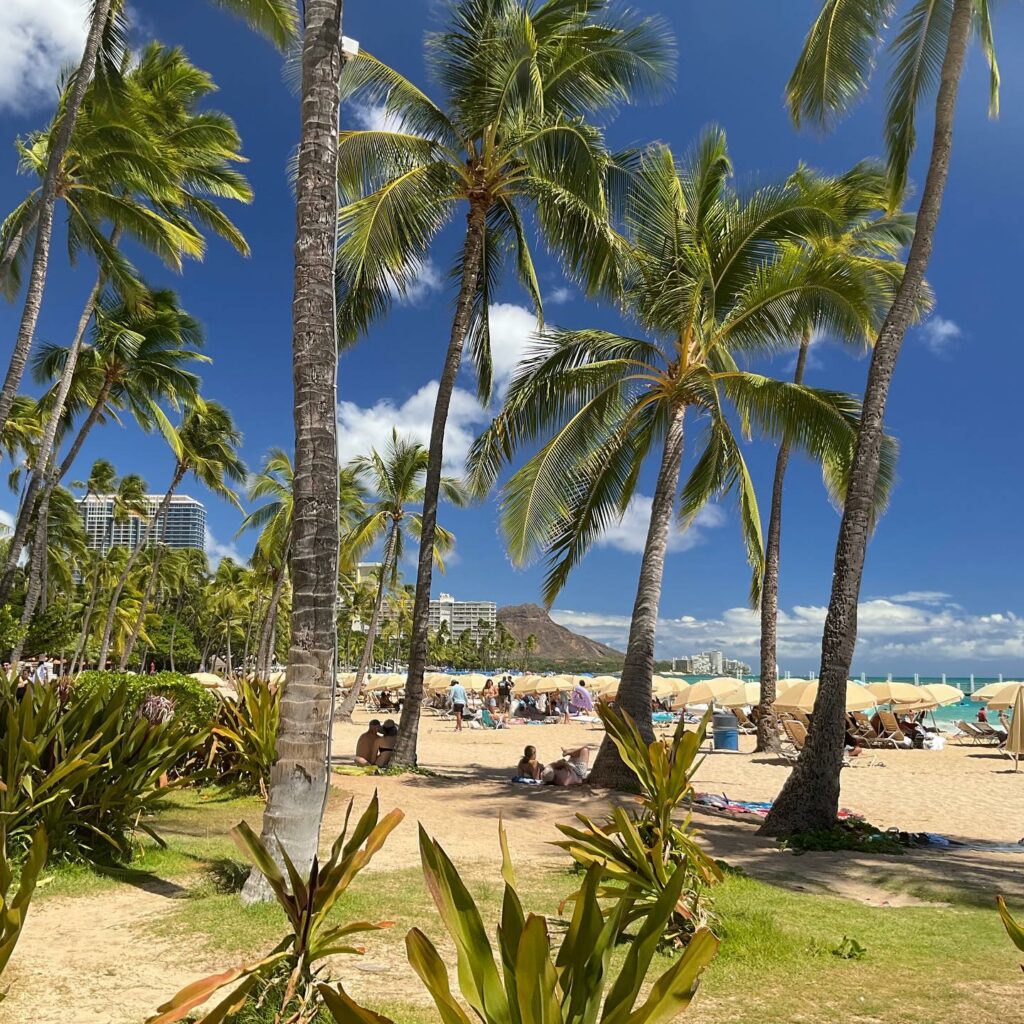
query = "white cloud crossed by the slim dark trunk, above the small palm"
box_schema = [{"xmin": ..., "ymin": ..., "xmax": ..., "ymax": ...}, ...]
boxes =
[{"xmin": 338, "ymin": 381, "xmax": 489, "ymax": 473}]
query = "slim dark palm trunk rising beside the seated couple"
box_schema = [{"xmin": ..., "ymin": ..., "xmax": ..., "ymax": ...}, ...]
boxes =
[{"xmin": 391, "ymin": 202, "xmax": 487, "ymax": 767}]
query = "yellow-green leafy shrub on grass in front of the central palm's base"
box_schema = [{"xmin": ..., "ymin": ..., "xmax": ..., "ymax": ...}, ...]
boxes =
[{"xmin": 555, "ymin": 705, "xmax": 722, "ymax": 946}]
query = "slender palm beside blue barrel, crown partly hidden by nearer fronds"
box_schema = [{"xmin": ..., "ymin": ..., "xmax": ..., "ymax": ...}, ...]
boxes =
[{"xmin": 757, "ymin": 164, "xmax": 913, "ymax": 751}]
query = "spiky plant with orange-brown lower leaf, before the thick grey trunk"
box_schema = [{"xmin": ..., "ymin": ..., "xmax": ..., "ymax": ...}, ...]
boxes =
[{"xmin": 146, "ymin": 793, "xmax": 403, "ymax": 1024}]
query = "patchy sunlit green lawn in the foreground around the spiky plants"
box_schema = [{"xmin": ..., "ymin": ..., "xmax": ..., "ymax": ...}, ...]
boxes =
[{"xmin": 42, "ymin": 793, "xmax": 1024, "ymax": 1024}]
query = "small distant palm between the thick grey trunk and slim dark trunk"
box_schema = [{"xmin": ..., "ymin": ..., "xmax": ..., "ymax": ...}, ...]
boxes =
[{"xmin": 336, "ymin": 429, "xmax": 467, "ymax": 722}]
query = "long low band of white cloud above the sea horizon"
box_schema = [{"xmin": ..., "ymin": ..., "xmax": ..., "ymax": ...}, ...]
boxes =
[{"xmin": 552, "ymin": 591, "xmax": 1024, "ymax": 675}]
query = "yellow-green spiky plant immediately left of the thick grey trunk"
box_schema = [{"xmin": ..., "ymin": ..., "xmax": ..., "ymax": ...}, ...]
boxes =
[{"xmin": 213, "ymin": 679, "xmax": 283, "ymax": 800}]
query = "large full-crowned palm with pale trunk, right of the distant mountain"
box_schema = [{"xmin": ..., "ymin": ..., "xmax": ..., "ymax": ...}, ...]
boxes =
[{"xmin": 470, "ymin": 129, "xmax": 888, "ymax": 787}]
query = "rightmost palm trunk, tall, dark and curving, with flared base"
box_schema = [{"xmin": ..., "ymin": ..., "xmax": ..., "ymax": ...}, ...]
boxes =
[{"xmin": 761, "ymin": 0, "xmax": 974, "ymax": 836}]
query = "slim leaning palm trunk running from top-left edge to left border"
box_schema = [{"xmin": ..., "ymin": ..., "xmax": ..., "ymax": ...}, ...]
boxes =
[{"xmin": 0, "ymin": 0, "xmax": 112, "ymax": 431}]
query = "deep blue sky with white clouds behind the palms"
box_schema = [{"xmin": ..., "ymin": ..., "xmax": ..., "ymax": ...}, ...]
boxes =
[{"xmin": 0, "ymin": 0, "xmax": 1024, "ymax": 676}]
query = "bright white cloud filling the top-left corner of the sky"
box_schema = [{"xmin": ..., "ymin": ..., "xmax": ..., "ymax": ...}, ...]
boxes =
[{"xmin": 0, "ymin": 0, "xmax": 88, "ymax": 113}]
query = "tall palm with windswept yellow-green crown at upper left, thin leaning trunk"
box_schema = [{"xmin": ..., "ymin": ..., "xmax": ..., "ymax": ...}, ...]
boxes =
[{"xmin": 0, "ymin": 44, "xmax": 252, "ymax": 600}]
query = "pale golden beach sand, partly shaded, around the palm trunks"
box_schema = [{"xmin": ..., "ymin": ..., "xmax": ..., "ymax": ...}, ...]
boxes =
[{"xmin": 0, "ymin": 716, "xmax": 1024, "ymax": 1024}]
